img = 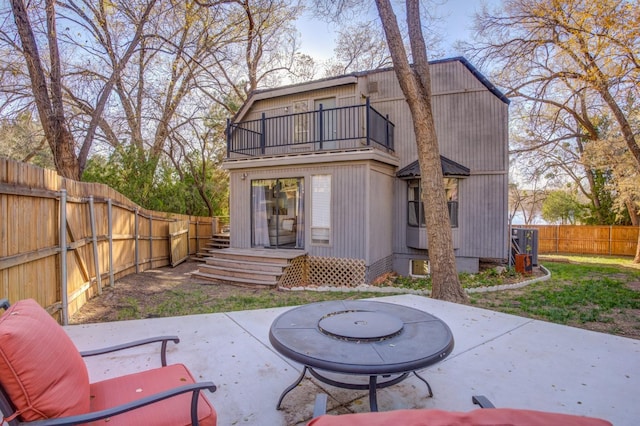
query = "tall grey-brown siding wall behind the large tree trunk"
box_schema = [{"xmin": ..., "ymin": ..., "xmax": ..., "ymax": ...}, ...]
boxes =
[{"xmin": 359, "ymin": 61, "xmax": 509, "ymax": 275}]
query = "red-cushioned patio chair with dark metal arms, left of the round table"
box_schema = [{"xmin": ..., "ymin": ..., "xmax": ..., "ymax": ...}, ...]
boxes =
[{"xmin": 0, "ymin": 299, "xmax": 217, "ymax": 426}]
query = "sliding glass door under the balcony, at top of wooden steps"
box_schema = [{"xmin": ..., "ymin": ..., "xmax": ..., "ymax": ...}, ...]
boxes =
[{"xmin": 251, "ymin": 178, "xmax": 304, "ymax": 249}]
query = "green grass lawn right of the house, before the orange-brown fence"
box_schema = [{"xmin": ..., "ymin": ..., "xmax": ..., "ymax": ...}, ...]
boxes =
[{"xmin": 470, "ymin": 256, "xmax": 640, "ymax": 339}]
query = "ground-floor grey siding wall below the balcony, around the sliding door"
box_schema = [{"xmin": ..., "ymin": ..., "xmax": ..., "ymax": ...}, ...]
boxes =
[{"xmin": 225, "ymin": 155, "xmax": 396, "ymax": 265}]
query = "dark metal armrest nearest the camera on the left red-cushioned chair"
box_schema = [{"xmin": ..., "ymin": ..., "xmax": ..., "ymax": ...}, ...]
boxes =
[{"xmin": 21, "ymin": 382, "xmax": 216, "ymax": 426}]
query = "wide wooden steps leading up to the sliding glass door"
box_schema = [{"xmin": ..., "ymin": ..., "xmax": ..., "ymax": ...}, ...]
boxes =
[{"xmin": 192, "ymin": 248, "xmax": 306, "ymax": 288}]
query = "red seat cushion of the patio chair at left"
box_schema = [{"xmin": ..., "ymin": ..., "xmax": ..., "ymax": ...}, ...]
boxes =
[{"xmin": 90, "ymin": 364, "xmax": 217, "ymax": 426}]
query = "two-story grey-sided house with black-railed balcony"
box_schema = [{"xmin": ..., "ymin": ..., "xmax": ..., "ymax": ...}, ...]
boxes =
[{"xmin": 196, "ymin": 58, "xmax": 509, "ymax": 286}]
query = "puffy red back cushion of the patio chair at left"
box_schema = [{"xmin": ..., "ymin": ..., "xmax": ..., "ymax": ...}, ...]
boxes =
[{"xmin": 0, "ymin": 299, "xmax": 89, "ymax": 421}]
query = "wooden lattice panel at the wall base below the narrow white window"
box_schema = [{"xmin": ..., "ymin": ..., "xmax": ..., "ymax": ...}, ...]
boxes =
[{"xmin": 309, "ymin": 256, "xmax": 366, "ymax": 287}]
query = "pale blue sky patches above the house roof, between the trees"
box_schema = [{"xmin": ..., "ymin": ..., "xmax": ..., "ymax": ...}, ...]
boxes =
[{"xmin": 297, "ymin": 0, "xmax": 501, "ymax": 61}]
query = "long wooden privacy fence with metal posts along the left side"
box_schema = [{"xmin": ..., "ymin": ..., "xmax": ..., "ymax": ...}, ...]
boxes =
[{"xmin": 0, "ymin": 158, "xmax": 218, "ymax": 324}]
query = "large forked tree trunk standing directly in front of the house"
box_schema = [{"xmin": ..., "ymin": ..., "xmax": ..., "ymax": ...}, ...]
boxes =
[{"xmin": 376, "ymin": 0, "xmax": 468, "ymax": 302}]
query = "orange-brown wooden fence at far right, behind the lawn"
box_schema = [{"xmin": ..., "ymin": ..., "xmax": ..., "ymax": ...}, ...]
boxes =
[{"xmin": 514, "ymin": 225, "xmax": 639, "ymax": 256}]
